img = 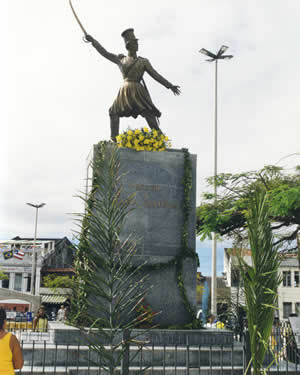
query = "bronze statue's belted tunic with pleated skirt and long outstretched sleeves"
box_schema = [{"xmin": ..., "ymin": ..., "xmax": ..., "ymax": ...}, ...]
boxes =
[{"xmin": 93, "ymin": 39, "xmax": 172, "ymax": 118}]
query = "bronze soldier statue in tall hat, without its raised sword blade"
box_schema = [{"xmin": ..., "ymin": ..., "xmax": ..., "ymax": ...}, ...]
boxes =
[{"xmin": 83, "ymin": 29, "xmax": 180, "ymax": 141}]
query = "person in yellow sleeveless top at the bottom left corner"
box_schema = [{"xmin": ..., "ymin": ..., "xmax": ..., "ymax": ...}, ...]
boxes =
[{"xmin": 0, "ymin": 308, "xmax": 24, "ymax": 375}]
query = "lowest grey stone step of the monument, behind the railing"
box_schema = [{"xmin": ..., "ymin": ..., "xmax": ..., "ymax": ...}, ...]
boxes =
[{"xmin": 23, "ymin": 344, "xmax": 243, "ymax": 368}]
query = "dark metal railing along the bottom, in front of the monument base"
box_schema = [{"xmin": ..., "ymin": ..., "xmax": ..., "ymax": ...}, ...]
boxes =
[{"xmin": 5, "ymin": 322, "xmax": 300, "ymax": 375}]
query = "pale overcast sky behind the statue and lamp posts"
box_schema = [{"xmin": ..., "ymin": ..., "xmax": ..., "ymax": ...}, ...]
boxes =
[{"xmin": 0, "ymin": 0, "xmax": 300, "ymax": 275}]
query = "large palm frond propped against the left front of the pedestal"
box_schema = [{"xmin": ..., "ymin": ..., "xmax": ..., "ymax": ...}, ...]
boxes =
[{"xmin": 70, "ymin": 143, "xmax": 153, "ymax": 374}]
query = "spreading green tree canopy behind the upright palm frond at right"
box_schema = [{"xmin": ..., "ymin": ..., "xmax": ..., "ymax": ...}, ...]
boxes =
[{"xmin": 197, "ymin": 165, "xmax": 300, "ymax": 251}]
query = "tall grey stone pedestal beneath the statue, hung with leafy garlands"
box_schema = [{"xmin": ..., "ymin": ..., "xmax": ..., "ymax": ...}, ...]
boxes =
[{"xmin": 95, "ymin": 148, "xmax": 197, "ymax": 327}]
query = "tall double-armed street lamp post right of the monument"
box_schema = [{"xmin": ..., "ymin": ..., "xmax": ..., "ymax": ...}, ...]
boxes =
[{"xmin": 199, "ymin": 46, "xmax": 233, "ymax": 315}]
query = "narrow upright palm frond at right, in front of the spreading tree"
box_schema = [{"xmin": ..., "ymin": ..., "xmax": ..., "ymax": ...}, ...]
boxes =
[{"xmin": 238, "ymin": 189, "xmax": 281, "ymax": 375}]
